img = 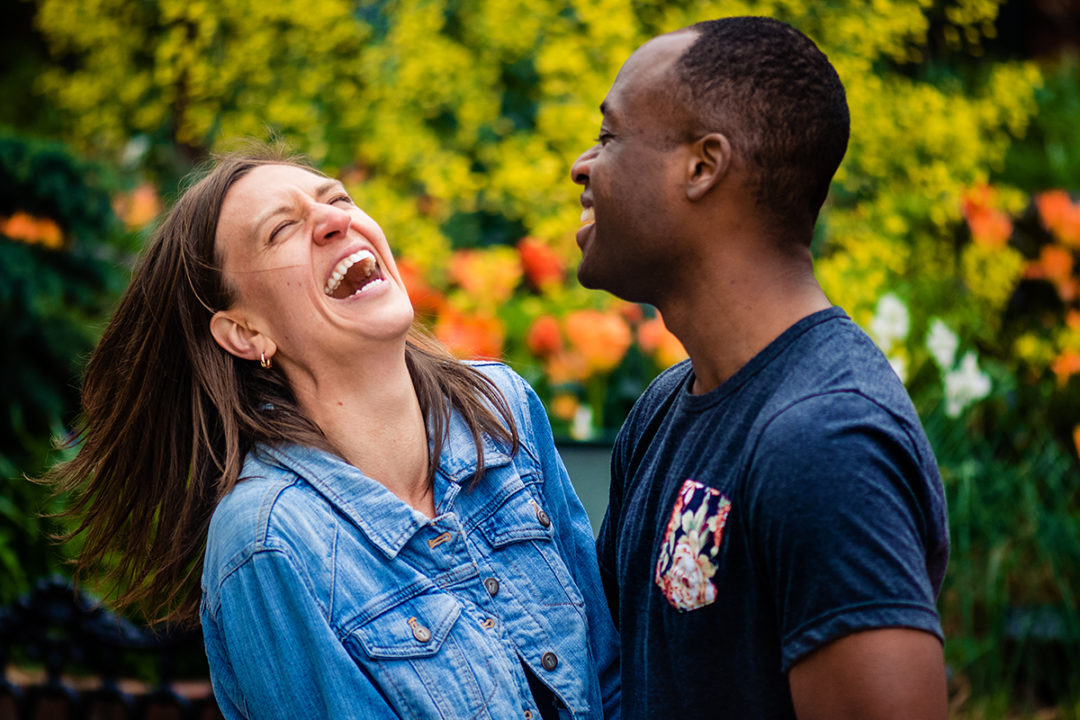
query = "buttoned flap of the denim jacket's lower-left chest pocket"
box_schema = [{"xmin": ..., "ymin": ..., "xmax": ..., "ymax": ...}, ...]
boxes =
[{"xmin": 352, "ymin": 593, "xmax": 461, "ymax": 657}]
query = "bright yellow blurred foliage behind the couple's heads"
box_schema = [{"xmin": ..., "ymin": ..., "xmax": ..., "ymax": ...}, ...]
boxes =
[{"xmin": 37, "ymin": 0, "xmax": 1040, "ymax": 416}]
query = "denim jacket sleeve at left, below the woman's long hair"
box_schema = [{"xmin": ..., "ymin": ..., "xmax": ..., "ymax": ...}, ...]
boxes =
[{"xmin": 202, "ymin": 551, "xmax": 397, "ymax": 720}]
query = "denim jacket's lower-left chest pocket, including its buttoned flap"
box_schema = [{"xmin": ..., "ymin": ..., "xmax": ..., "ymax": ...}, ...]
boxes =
[{"xmin": 345, "ymin": 593, "xmax": 499, "ymax": 718}]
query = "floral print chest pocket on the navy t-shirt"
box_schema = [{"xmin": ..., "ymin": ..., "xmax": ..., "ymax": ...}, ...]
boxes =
[{"xmin": 654, "ymin": 479, "xmax": 731, "ymax": 612}]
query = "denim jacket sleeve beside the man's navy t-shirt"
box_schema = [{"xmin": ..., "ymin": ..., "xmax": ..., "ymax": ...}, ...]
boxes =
[{"xmin": 519, "ymin": 380, "xmax": 621, "ymax": 720}]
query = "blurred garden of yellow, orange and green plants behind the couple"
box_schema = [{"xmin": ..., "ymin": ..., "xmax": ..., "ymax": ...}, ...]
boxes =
[{"xmin": 0, "ymin": 0, "xmax": 1080, "ymax": 718}]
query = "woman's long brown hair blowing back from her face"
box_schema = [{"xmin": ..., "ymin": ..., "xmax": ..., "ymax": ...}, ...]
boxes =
[{"xmin": 44, "ymin": 148, "xmax": 518, "ymax": 624}]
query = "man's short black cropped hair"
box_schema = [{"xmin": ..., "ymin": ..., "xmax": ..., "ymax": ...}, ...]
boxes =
[{"xmin": 674, "ymin": 17, "xmax": 850, "ymax": 240}]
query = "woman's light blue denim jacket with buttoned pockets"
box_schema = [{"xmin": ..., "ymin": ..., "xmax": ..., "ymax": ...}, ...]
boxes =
[{"xmin": 201, "ymin": 363, "xmax": 619, "ymax": 720}]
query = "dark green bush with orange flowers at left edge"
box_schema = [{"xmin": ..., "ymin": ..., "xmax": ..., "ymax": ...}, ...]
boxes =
[{"xmin": 0, "ymin": 134, "xmax": 126, "ymax": 604}]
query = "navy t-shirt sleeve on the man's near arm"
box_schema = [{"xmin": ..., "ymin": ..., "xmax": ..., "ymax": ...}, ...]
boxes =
[{"xmin": 744, "ymin": 392, "xmax": 942, "ymax": 673}]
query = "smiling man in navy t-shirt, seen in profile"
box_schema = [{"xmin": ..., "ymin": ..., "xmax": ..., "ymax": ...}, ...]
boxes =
[{"xmin": 571, "ymin": 17, "xmax": 948, "ymax": 720}]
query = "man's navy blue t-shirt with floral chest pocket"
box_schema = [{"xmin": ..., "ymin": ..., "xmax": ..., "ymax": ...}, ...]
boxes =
[{"xmin": 597, "ymin": 308, "xmax": 948, "ymax": 720}]
